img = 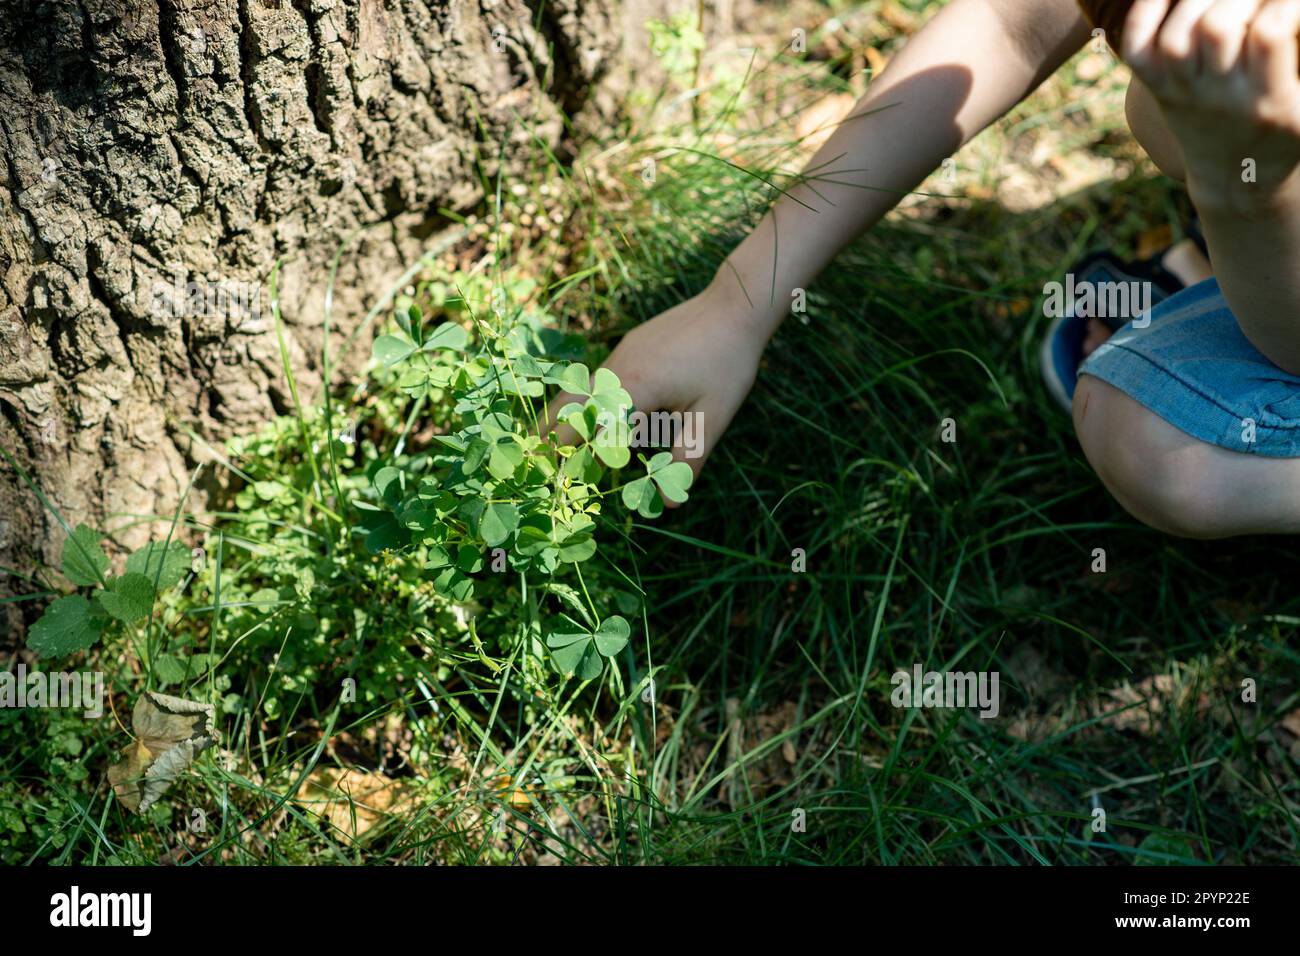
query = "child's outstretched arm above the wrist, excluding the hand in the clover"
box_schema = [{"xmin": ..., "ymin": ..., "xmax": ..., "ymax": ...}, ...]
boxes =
[{"xmin": 715, "ymin": 0, "xmax": 1088, "ymax": 341}]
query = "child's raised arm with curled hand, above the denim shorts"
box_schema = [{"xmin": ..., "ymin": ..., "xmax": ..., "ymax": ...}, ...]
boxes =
[{"xmin": 1123, "ymin": 0, "xmax": 1300, "ymax": 375}]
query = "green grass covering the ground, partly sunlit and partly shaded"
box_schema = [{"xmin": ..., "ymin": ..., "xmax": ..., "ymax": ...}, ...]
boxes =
[{"xmin": 0, "ymin": 7, "xmax": 1300, "ymax": 865}]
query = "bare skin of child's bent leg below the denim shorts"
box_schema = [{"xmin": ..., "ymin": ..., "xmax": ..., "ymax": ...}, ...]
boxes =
[{"xmin": 1074, "ymin": 375, "xmax": 1300, "ymax": 537}]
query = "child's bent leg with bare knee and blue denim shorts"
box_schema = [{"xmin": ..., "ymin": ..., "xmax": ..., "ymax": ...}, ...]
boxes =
[{"xmin": 1074, "ymin": 280, "xmax": 1300, "ymax": 537}]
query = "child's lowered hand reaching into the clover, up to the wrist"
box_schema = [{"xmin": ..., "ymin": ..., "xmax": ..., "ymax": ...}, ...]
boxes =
[{"xmin": 546, "ymin": 287, "xmax": 766, "ymax": 489}]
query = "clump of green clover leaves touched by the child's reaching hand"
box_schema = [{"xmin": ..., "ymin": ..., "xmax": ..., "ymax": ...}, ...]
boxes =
[{"xmin": 364, "ymin": 299, "xmax": 692, "ymax": 680}]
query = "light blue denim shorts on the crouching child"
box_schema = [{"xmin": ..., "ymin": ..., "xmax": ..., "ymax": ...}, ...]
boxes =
[{"xmin": 1079, "ymin": 278, "xmax": 1300, "ymax": 458}]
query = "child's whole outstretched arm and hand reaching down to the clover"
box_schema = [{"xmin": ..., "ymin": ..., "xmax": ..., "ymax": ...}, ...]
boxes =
[{"xmin": 551, "ymin": 0, "xmax": 1088, "ymax": 472}]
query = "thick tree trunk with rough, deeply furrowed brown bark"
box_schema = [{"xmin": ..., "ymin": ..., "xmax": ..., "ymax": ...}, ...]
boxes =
[{"xmin": 0, "ymin": 0, "xmax": 702, "ymax": 624}]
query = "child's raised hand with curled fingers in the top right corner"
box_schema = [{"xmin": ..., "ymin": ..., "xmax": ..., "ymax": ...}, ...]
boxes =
[{"xmin": 1122, "ymin": 0, "xmax": 1300, "ymax": 208}]
